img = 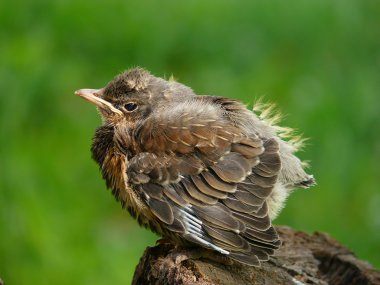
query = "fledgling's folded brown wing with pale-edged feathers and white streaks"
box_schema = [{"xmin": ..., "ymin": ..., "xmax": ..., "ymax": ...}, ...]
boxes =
[{"xmin": 127, "ymin": 98, "xmax": 281, "ymax": 265}]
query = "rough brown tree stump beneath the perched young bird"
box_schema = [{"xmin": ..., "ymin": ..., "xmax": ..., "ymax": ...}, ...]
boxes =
[{"xmin": 132, "ymin": 227, "xmax": 380, "ymax": 285}]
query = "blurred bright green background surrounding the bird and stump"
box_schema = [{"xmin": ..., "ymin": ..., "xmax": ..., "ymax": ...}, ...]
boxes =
[{"xmin": 0, "ymin": 0, "xmax": 380, "ymax": 285}]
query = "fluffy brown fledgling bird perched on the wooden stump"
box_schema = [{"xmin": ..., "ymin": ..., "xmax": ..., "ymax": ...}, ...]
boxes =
[{"xmin": 75, "ymin": 67, "xmax": 315, "ymax": 266}]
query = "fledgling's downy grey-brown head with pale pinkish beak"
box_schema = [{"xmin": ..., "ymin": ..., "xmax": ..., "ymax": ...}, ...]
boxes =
[{"xmin": 75, "ymin": 68, "xmax": 194, "ymax": 128}]
